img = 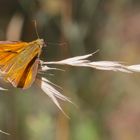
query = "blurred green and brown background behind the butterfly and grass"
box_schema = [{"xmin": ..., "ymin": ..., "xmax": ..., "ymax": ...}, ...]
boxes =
[{"xmin": 0, "ymin": 0, "xmax": 140, "ymax": 140}]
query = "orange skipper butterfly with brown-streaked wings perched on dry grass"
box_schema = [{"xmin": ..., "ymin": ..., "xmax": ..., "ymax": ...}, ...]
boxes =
[{"xmin": 0, "ymin": 39, "xmax": 44, "ymax": 89}]
